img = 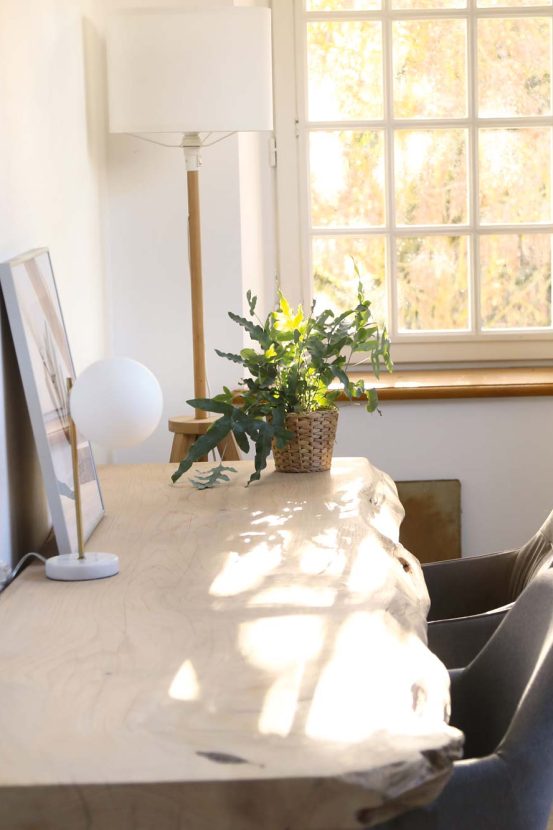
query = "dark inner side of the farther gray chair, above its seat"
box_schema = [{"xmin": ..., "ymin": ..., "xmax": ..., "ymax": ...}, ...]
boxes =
[{"xmin": 422, "ymin": 550, "xmax": 518, "ymax": 620}]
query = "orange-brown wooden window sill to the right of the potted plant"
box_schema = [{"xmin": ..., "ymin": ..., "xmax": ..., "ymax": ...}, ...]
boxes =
[{"xmin": 348, "ymin": 366, "xmax": 553, "ymax": 401}]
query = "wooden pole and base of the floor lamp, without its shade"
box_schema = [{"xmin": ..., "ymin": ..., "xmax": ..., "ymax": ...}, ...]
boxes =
[{"xmin": 169, "ymin": 133, "xmax": 240, "ymax": 462}]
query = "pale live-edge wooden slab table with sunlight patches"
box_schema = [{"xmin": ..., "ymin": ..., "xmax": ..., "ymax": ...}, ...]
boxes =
[{"xmin": 0, "ymin": 458, "xmax": 462, "ymax": 830}]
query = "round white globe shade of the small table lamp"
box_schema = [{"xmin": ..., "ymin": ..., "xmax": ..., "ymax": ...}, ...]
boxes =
[{"xmin": 70, "ymin": 357, "xmax": 163, "ymax": 449}]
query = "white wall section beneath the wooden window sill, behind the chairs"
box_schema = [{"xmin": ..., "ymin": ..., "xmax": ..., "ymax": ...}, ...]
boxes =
[{"xmin": 336, "ymin": 397, "xmax": 553, "ymax": 556}]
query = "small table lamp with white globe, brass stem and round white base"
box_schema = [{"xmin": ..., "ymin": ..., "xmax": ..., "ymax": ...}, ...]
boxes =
[{"xmin": 46, "ymin": 357, "xmax": 163, "ymax": 582}]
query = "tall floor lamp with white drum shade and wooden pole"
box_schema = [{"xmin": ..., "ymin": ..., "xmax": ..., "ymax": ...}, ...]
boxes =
[{"xmin": 107, "ymin": 7, "xmax": 273, "ymax": 461}]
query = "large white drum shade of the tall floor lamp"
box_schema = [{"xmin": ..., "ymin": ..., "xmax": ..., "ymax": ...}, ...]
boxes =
[{"xmin": 107, "ymin": 7, "xmax": 273, "ymax": 133}]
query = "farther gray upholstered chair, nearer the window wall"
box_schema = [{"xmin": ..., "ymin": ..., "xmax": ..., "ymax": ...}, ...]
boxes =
[{"xmin": 423, "ymin": 511, "xmax": 553, "ymax": 669}]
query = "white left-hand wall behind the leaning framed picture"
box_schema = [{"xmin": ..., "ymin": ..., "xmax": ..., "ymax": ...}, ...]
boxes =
[{"xmin": 0, "ymin": 0, "xmax": 105, "ymax": 562}]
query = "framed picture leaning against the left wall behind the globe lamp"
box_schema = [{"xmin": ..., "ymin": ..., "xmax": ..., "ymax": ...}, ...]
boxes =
[{"xmin": 0, "ymin": 248, "xmax": 104, "ymax": 553}]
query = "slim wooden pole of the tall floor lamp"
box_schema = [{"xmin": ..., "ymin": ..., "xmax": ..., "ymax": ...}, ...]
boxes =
[{"xmin": 186, "ymin": 169, "xmax": 207, "ymax": 420}]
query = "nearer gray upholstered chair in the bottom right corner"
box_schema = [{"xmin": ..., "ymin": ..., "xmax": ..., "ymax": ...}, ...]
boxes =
[{"xmin": 378, "ymin": 570, "xmax": 553, "ymax": 830}]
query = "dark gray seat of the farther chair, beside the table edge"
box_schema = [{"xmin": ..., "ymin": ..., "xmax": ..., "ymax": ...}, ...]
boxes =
[{"xmin": 428, "ymin": 605, "xmax": 511, "ymax": 672}]
